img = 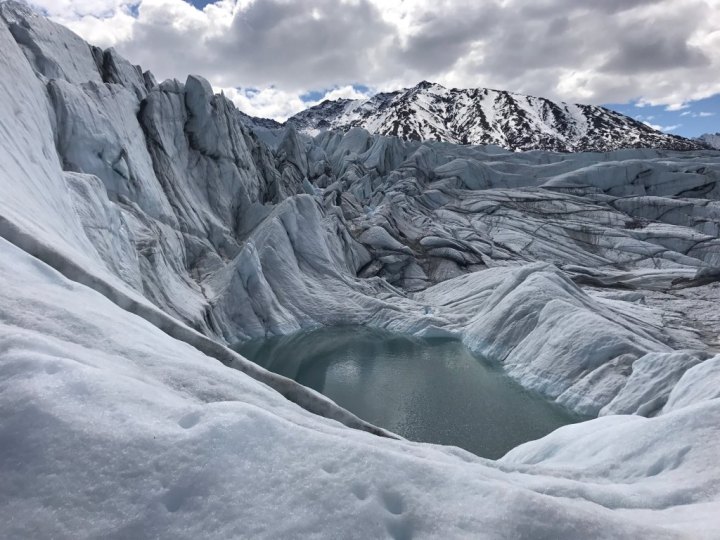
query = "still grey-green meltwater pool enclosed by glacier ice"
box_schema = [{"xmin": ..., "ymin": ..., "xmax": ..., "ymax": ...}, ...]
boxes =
[{"xmin": 237, "ymin": 327, "xmax": 579, "ymax": 459}]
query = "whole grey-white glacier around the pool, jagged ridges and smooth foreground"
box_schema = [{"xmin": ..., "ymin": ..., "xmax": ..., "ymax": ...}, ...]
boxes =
[{"xmin": 0, "ymin": 1, "xmax": 720, "ymax": 538}]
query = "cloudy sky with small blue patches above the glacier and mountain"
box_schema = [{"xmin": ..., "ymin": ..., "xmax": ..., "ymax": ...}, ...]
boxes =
[{"xmin": 30, "ymin": 0, "xmax": 720, "ymax": 135}]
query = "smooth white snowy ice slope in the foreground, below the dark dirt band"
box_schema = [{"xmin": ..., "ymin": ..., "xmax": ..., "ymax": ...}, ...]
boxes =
[{"xmin": 5, "ymin": 237, "xmax": 720, "ymax": 538}]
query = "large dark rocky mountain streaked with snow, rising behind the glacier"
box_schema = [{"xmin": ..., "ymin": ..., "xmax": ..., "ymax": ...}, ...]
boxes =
[{"xmin": 288, "ymin": 81, "xmax": 704, "ymax": 152}]
